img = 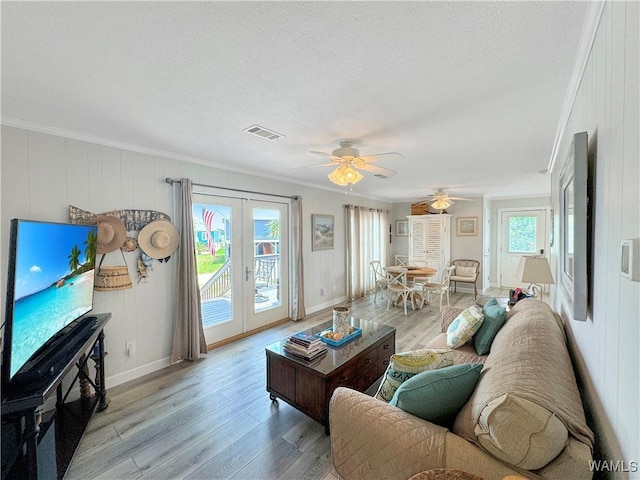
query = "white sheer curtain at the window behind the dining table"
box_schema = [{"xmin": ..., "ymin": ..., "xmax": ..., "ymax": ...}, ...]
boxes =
[{"xmin": 345, "ymin": 205, "xmax": 389, "ymax": 300}]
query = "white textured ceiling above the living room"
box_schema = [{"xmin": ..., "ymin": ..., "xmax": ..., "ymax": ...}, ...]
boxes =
[{"xmin": 1, "ymin": 1, "xmax": 587, "ymax": 202}]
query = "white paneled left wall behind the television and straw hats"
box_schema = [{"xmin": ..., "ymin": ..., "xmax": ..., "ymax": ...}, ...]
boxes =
[{"xmin": 0, "ymin": 126, "xmax": 391, "ymax": 387}]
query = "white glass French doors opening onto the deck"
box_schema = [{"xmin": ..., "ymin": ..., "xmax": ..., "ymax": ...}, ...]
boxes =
[{"xmin": 193, "ymin": 194, "xmax": 289, "ymax": 344}]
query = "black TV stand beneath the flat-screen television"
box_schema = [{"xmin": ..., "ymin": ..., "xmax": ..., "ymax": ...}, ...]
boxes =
[{"xmin": 1, "ymin": 313, "xmax": 111, "ymax": 480}]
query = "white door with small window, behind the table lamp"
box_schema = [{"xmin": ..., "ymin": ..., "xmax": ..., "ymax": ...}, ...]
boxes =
[{"xmin": 499, "ymin": 208, "xmax": 548, "ymax": 288}]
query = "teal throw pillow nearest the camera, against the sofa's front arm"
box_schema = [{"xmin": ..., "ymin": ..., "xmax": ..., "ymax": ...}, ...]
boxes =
[{"xmin": 389, "ymin": 363, "xmax": 482, "ymax": 427}]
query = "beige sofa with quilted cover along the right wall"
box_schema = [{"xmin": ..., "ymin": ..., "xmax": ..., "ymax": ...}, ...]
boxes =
[{"xmin": 329, "ymin": 299, "xmax": 594, "ymax": 480}]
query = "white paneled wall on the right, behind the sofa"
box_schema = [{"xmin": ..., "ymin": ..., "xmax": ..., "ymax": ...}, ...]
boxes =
[{"xmin": 552, "ymin": 2, "xmax": 640, "ymax": 468}]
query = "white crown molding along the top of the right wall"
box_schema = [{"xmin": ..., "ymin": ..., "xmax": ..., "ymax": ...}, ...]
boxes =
[{"xmin": 546, "ymin": 0, "xmax": 607, "ymax": 173}]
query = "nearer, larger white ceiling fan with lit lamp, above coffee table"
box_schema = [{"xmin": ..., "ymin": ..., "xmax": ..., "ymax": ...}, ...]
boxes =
[{"xmin": 301, "ymin": 140, "xmax": 402, "ymax": 187}]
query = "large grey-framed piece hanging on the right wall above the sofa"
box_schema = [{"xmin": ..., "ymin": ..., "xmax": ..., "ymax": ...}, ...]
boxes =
[{"xmin": 559, "ymin": 132, "xmax": 589, "ymax": 321}]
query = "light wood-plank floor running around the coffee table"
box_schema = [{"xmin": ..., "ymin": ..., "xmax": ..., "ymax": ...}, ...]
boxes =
[{"xmin": 65, "ymin": 293, "xmax": 484, "ymax": 480}]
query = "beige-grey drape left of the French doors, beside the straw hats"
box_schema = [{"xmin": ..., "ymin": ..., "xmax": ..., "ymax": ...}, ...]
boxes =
[{"xmin": 171, "ymin": 178, "xmax": 207, "ymax": 363}]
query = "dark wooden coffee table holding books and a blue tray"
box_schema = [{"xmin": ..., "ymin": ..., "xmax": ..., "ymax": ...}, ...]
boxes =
[{"xmin": 266, "ymin": 317, "xmax": 396, "ymax": 434}]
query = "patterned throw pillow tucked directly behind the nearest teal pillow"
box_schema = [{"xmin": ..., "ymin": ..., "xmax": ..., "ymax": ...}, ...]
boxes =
[{"xmin": 375, "ymin": 349, "xmax": 454, "ymax": 402}]
